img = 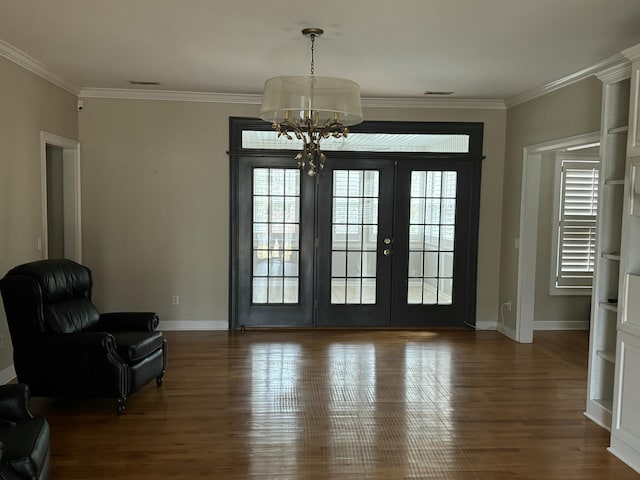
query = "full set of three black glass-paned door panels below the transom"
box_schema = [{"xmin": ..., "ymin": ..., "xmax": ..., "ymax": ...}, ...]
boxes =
[{"xmin": 230, "ymin": 118, "xmax": 482, "ymax": 329}]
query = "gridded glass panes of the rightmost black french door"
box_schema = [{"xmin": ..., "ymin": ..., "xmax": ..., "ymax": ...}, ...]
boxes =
[{"xmin": 407, "ymin": 171, "xmax": 457, "ymax": 305}]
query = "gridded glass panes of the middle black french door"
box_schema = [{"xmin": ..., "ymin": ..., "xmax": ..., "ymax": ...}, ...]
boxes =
[{"xmin": 331, "ymin": 170, "xmax": 380, "ymax": 305}]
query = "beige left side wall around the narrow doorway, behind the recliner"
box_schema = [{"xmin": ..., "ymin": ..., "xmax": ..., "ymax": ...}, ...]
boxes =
[{"xmin": 0, "ymin": 57, "xmax": 78, "ymax": 373}]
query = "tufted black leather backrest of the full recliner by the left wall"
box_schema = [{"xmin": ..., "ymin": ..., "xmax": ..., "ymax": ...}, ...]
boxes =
[{"xmin": 2, "ymin": 259, "xmax": 100, "ymax": 333}]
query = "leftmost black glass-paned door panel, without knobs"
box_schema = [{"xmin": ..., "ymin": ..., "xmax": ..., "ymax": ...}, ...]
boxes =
[{"xmin": 230, "ymin": 156, "xmax": 315, "ymax": 327}]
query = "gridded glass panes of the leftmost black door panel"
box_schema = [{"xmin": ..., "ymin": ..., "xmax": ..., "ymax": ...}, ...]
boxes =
[{"xmin": 251, "ymin": 168, "xmax": 300, "ymax": 304}]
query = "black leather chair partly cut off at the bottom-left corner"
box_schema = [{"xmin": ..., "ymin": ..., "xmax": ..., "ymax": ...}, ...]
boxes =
[{"xmin": 0, "ymin": 384, "xmax": 51, "ymax": 480}]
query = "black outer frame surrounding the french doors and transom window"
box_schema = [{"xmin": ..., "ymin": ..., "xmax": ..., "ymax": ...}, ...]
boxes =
[{"xmin": 227, "ymin": 117, "xmax": 484, "ymax": 330}]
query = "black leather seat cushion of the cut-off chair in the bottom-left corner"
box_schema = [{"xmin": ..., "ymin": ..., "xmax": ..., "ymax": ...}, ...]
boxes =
[{"xmin": 0, "ymin": 417, "xmax": 50, "ymax": 478}]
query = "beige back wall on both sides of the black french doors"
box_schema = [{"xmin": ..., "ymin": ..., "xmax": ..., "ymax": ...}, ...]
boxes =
[{"xmin": 79, "ymin": 99, "xmax": 506, "ymax": 327}]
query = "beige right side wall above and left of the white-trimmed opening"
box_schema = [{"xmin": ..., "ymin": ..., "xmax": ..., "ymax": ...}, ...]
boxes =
[{"xmin": 499, "ymin": 77, "xmax": 602, "ymax": 331}]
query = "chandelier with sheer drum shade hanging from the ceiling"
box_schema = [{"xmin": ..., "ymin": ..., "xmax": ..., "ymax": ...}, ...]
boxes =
[{"xmin": 260, "ymin": 28, "xmax": 362, "ymax": 176}]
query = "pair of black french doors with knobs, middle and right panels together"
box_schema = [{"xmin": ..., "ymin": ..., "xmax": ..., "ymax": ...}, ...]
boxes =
[{"xmin": 316, "ymin": 157, "xmax": 477, "ymax": 327}]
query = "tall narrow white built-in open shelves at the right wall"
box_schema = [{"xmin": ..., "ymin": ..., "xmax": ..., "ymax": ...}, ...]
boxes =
[{"xmin": 585, "ymin": 66, "xmax": 630, "ymax": 429}]
